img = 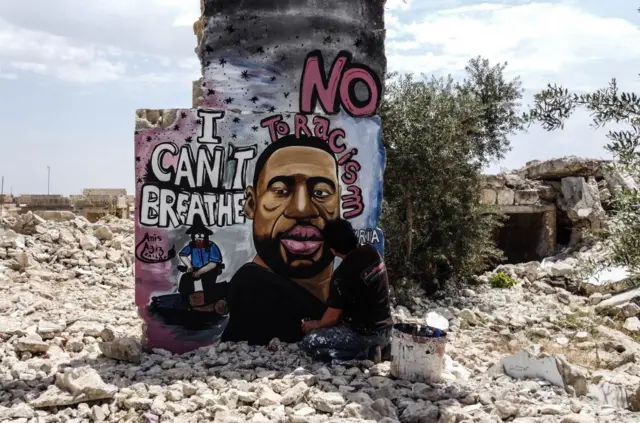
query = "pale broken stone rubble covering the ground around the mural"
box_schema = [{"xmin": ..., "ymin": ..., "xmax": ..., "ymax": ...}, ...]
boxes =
[{"xmin": 0, "ymin": 210, "xmax": 640, "ymax": 423}]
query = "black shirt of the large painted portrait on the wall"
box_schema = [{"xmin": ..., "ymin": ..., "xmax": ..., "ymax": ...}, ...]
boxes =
[{"xmin": 222, "ymin": 263, "xmax": 326, "ymax": 345}]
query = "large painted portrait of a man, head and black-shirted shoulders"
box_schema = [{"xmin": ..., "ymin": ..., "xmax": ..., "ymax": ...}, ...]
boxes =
[{"xmin": 222, "ymin": 135, "xmax": 340, "ymax": 344}]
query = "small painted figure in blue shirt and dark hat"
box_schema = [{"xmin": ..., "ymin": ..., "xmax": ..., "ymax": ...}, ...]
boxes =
[{"xmin": 178, "ymin": 215, "xmax": 225, "ymax": 314}]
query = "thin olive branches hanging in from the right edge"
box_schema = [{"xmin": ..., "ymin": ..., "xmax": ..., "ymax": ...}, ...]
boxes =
[{"xmin": 524, "ymin": 55, "xmax": 640, "ymax": 275}]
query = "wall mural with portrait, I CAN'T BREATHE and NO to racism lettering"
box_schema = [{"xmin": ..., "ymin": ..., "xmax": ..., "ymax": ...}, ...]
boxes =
[{"xmin": 135, "ymin": 51, "xmax": 385, "ymax": 352}]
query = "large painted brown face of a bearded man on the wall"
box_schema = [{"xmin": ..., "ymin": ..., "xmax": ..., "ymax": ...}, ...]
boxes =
[{"xmin": 245, "ymin": 147, "xmax": 340, "ymax": 279}]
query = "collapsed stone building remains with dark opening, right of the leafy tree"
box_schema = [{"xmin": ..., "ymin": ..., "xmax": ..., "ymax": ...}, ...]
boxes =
[{"xmin": 480, "ymin": 156, "xmax": 638, "ymax": 263}]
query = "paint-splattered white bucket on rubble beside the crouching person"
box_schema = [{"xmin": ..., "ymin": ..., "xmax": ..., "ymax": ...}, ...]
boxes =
[{"xmin": 391, "ymin": 323, "xmax": 447, "ymax": 382}]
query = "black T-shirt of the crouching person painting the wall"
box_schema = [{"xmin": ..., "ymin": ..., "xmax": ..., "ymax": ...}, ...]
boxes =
[{"xmin": 327, "ymin": 244, "xmax": 393, "ymax": 334}]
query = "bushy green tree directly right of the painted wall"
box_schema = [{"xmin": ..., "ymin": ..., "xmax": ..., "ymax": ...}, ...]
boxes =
[{"xmin": 380, "ymin": 58, "xmax": 523, "ymax": 289}]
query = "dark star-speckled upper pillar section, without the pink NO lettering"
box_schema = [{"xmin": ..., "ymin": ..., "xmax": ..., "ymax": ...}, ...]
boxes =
[{"xmin": 194, "ymin": 0, "xmax": 387, "ymax": 112}]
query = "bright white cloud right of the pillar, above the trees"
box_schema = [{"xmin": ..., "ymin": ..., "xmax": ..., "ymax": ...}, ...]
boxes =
[{"xmin": 387, "ymin": 2, "xmax": 640, "ymax": 88}]
